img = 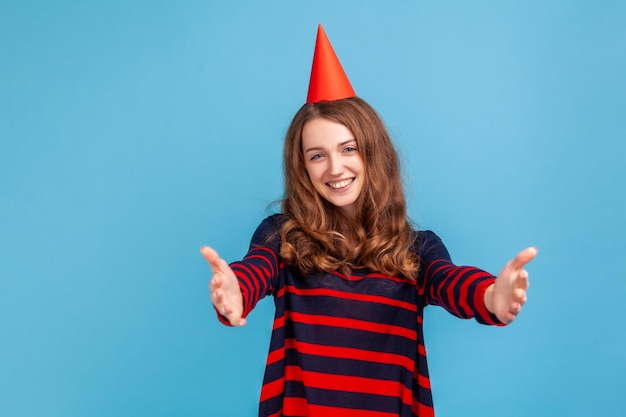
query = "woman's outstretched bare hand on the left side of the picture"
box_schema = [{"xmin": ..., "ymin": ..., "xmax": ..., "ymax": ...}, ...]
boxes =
[{"xmin": 200, "ymin": 246, "xmax": 246, "ymax": 326}]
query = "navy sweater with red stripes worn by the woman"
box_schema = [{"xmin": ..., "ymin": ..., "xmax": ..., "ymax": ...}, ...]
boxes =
[{"xmin": 220, "ymin": 215, "xmax": 500, "ymax": 417}]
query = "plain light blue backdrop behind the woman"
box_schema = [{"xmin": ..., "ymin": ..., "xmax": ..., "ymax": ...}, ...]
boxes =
[{"xmin": 0, "ymin": 0, "xmax": 626, "ymax": 417}]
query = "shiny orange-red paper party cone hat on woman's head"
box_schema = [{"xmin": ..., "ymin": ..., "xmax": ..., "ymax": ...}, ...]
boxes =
[{"xmin": 306, "ymin": 25, "xmax": 356, "ymax": 103}]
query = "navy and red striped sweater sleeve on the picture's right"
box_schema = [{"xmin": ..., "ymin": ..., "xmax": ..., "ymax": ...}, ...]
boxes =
[{"xmin": 418, "ymin": 231, "xmax": 504, "ymax": 325}]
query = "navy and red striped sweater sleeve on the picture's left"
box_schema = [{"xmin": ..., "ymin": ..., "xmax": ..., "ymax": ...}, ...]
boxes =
[{"xmin": 216, "ymin": 216, "xmax": 280, "ymax": 325}]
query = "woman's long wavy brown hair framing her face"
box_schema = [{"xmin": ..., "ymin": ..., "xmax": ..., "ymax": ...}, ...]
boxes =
[{"xmin": 280, "ymin": 97, "xmax": 419, "ymax": 279}]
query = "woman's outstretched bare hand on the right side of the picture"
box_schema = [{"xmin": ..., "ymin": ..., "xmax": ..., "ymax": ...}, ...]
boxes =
[{"xmin": 485, "ymin": 247, "xmax": 537, "ymax": 323}]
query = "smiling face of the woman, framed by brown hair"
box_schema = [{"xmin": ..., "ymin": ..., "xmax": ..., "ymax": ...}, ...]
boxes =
[{"xmin": 302, "ymin": 118, "xmax": 365, "ymax": 218}]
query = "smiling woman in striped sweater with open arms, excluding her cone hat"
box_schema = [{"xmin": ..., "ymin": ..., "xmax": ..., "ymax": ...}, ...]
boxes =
[{"xmin": 201, "ymin": 25, "xmax": 537, "ymax": 417}]
